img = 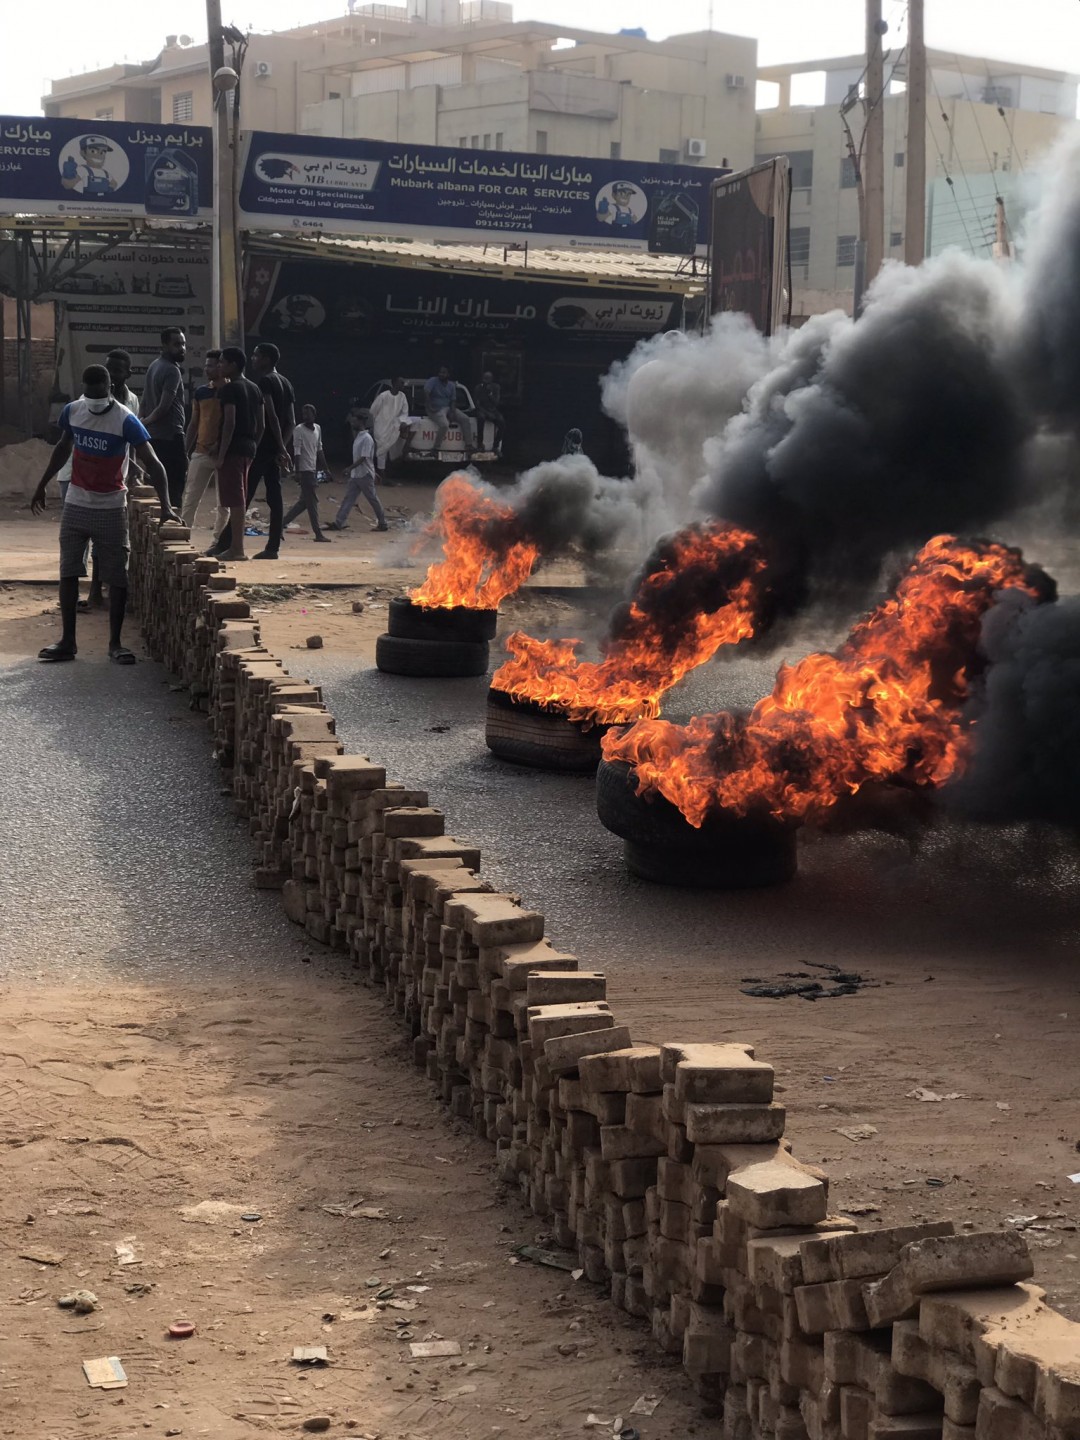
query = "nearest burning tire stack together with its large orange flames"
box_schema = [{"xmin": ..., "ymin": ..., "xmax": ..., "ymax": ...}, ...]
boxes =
[{"xmin": 598, "ymin": 536, "xmax": 1056, "ymax": 887}]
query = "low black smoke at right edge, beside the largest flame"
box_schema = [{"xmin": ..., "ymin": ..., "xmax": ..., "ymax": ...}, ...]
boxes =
[{"xmin": 940, "ymin": 590, "xmax": 1080, "ymax": 831}]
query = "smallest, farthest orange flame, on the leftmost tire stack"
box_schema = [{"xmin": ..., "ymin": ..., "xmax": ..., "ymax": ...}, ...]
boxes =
[{"xmin": 409, "ymin": 471, "xmax": 540, "ymax": 611}]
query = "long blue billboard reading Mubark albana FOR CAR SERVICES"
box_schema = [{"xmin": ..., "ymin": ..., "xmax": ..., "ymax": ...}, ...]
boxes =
[{"xmin": 240, "ymin": 131, "xmax": 727, "ymax": 255}]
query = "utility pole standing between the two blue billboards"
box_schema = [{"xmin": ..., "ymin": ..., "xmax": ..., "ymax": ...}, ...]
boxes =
[{"xmin": 206, "ymin": 0, "xmax": 242, "ymax": 346}]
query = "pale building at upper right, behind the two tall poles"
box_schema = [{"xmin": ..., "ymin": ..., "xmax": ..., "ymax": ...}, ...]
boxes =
[{"xmin": 756, "ymin": 50, "xmax": 1080, "ymax": 314}]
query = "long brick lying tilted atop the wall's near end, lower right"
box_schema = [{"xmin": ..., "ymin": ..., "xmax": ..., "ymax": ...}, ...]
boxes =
[{"xmin": 864, "ymin": 1231, "xmax": 1034, "ymax": 1326}]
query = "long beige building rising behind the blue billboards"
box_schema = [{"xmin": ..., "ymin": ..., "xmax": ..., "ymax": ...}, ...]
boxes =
[{"xmin": 43, "ymin": 0, "xmax": 757, "ymax": 168}]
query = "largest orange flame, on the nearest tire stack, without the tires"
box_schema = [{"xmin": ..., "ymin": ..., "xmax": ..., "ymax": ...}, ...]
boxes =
[{"xmin": 603, "ymin": 536, "xmax": 1038, "ymax": 827}]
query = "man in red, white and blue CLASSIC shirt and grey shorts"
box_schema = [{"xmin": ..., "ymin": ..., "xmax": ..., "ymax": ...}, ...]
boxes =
[{"xmin": 30, "ymin": 364, "xmax": 180, "ymax": 665}]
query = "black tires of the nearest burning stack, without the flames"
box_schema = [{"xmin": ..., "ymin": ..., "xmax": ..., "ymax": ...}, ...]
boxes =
[{"xmin": 596, "ymin": 760, "xmax": 796, "ymax": 890}]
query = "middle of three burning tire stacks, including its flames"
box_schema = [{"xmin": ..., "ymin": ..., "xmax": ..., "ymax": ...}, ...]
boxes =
[{"xmin": 487, "ymin": 521, "xmax": 766, "ymax": 770}]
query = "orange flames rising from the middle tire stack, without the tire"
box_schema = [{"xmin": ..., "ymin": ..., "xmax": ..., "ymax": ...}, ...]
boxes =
[{"xmin": 491, "ymin": 523, "xmax": 765, "ymax": 726}]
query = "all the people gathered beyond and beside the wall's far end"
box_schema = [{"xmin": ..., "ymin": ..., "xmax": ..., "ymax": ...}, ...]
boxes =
[{"xmin": 30, "ymin": 338, "xmax": 544, "ymax": 665}]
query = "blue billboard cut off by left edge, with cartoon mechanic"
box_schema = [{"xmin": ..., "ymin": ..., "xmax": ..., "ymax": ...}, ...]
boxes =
[{"xmin": 0, "ymin": 115, "xmax": 213, "ymax": 222}]
